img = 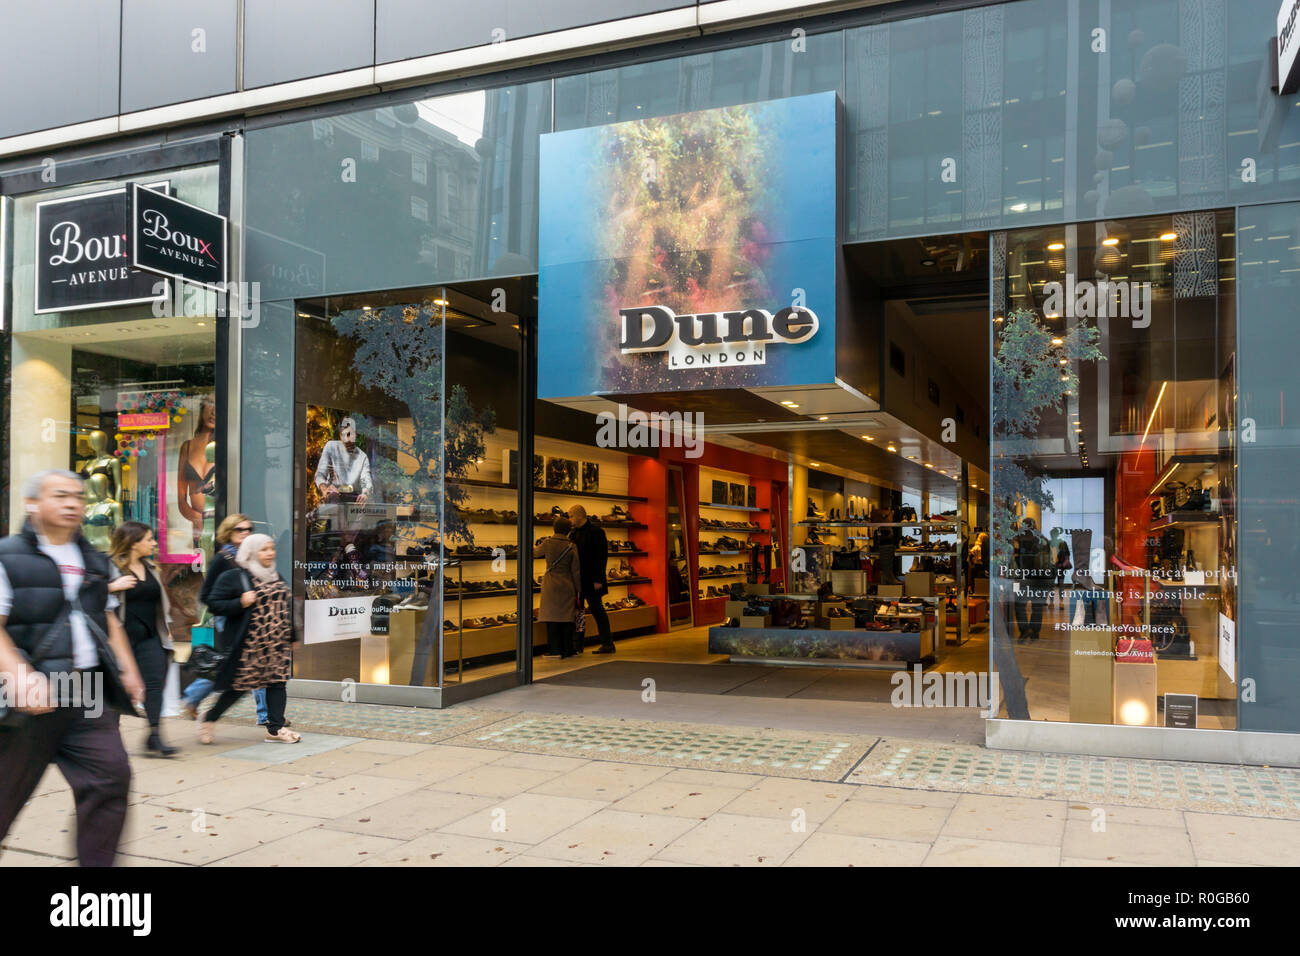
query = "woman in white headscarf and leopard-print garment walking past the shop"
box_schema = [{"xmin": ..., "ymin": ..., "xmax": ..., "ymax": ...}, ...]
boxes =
[{"xmin": 199, "ymin": 535, "xmax": 302, "ymax": 744}]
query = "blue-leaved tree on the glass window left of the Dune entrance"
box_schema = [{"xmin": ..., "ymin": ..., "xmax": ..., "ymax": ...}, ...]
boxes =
[{"xmin": 333, "ymin": 299, "xmax": 497, "ymax": 685}]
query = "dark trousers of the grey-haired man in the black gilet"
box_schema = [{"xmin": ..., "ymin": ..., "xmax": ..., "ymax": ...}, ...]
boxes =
[{"xmin": 0, "ymin": 706, "xmax": 131, "ymax": 866}]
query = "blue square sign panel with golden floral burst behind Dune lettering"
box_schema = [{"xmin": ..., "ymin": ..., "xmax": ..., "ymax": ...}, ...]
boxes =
[{"xmin": 538, "ymin": 92, "xmax": 839, "ymax": 398}]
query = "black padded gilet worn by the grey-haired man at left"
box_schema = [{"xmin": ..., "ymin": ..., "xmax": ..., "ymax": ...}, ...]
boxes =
[{"xmin": 0, "ymin": 522, "xmax": 109, "ymax": 674}]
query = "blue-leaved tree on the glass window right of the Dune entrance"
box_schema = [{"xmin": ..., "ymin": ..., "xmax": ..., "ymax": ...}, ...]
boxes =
[{"xmin": 989, "ymin": 310, "xmax": 1105, "ymax": 719}]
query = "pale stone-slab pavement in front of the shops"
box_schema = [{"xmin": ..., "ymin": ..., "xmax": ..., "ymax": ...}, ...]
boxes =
[{"xmin": 0, "ymin": 685, "xmax": 1300, "ymax": 866}]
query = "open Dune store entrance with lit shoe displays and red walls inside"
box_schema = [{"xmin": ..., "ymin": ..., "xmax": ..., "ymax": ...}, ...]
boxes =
[{"xmin": 534, "ymin": 234, "xmax": 989, "ymax": 704}]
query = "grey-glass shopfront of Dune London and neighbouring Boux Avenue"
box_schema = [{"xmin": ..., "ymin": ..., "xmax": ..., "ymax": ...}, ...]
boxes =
[{"xmin": 0, "ymin": 0, "xmax": 1300, "ymax": 760}]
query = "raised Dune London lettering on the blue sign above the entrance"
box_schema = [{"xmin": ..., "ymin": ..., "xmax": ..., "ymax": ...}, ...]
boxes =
[{"xmin": 619, "ymin": 306, "xmax": 820, "ymax": 371}]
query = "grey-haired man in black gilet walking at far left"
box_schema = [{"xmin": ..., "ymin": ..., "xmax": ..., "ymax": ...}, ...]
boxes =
[{"xmin": 0, "ymin": 471, "xmax": 144, "ymax": 866}]
